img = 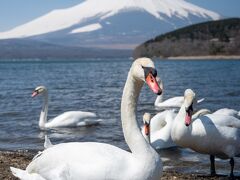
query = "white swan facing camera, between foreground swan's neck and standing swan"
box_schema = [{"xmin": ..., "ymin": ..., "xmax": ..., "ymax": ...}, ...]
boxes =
[{"xmin": 142, "ymin": 109, "xmax": 210, "ymax": 149}]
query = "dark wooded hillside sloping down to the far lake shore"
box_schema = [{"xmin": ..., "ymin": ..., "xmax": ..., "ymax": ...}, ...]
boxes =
[{"xmin": 133, "ymin": 18, "xmax": 240, "ymax": 58}]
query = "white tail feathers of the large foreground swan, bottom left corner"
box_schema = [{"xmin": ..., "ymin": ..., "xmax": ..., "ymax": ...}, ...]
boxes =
[{"xmin": 10, "ymin": 167, "xmax": 46, "ymax": 180}]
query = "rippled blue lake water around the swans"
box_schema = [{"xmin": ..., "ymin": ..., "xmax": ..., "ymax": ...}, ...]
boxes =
[{"xmin": 0, "ymin": 59, "xmax": 240, "ymax": 176}]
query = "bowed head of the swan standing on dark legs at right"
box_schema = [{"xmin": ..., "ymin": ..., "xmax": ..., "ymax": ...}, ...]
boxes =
[{"xmin": 183, "ymin": 89, "xmax": 196, "ymax": 126}]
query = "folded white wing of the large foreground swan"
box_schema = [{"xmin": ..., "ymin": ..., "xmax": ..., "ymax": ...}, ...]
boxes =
[{"xmin": 26, "ymin": 143, "xmax": 139, "ymax": 179}]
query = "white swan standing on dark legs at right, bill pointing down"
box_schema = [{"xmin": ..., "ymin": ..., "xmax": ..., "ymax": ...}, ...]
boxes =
[{"xmin": 171, "ymin": 89, "xmax": 240, "ymax": 176}]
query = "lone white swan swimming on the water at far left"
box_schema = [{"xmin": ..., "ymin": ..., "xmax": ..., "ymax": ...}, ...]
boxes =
[{"xmin": 32, "ymin": 86, "xmax": 102, "ymax": 129}]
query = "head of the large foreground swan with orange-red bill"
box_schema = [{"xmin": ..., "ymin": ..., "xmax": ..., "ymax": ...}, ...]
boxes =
[{"xmin": 131, "ymin": 58, "xmax": 162, "ymax": 95}]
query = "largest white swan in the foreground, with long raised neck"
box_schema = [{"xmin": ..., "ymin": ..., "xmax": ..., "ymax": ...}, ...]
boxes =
[{"xmin": 11, "ymin": 58, "xmax": 162, "ymax": 180}]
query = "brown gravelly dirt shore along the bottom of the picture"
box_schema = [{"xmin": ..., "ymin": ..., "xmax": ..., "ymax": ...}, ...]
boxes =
[{"xmin": 0, "ymin": 151, "xmax": 240, "ymax": 180}]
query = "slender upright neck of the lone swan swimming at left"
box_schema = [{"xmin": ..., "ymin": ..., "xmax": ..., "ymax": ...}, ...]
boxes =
[{"xmin": 39, "ymin": 91, "xmax": 48, "ymax": 129}]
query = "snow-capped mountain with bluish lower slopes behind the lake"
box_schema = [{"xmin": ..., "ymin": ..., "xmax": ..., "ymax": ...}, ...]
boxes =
[{"xmin": 0, "ymin": 0, "xmax": 221, "ymax": 48}]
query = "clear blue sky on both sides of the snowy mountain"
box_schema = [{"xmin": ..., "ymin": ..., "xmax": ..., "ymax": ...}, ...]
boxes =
[{"xmin": 0, "ymin": 0, "xmax": 240, "ymax": 32}]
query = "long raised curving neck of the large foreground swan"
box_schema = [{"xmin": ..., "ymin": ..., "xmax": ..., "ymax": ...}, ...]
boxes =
[{"xmin": 121, "ymin": 71, "xmax": 154, "ymax": 155}]
